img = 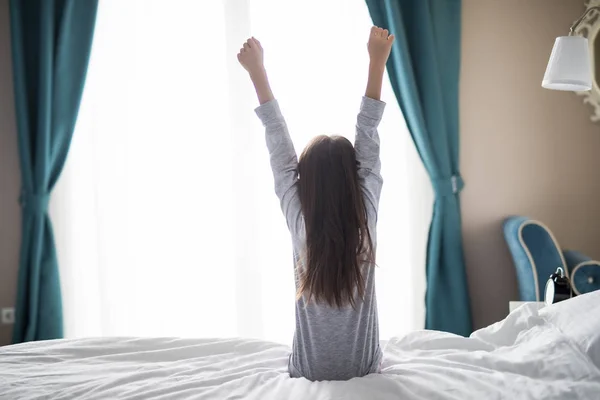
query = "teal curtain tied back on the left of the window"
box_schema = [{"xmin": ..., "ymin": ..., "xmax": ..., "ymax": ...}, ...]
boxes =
[{"xmin": 10, "ymin": 0, "xmax": 98, "ymax": 343}]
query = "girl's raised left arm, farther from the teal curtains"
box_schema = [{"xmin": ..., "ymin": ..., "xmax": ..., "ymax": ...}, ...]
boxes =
[{"xmin": 238, "ymin": 38, "xmax": 303, "ymax": 235}]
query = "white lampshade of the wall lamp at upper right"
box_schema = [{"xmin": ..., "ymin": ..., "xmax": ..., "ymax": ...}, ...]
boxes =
[{"xmin": 542, "ymin": 36, "xmax": 592, "ymax": 92}]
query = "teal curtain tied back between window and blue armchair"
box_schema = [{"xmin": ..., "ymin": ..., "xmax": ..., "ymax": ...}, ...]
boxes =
[{"xmin": 367, "ymin": 0, "xmax": 472, "ymax": 335}]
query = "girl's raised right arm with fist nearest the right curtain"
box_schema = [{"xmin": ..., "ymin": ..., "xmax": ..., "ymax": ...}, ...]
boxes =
[{"xmin": 354, "ymin": 26, "xmax": 394, "ymax": 218}]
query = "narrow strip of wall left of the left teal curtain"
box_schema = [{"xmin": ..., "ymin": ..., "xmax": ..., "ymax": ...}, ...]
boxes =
[{"xmin": 0, "ymin": 0, "xmax": 21, "ymax": 346}]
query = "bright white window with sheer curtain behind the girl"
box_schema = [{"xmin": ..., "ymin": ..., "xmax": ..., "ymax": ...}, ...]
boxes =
[{"xmin": 51, "ymin": 0, "xmax": 432, "ymax": 343}]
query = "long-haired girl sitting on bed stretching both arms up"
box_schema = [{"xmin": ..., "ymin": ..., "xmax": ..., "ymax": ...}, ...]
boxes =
[{"xmin": 238, "ymin": 27, "xmax": 394, "ymax": 381}]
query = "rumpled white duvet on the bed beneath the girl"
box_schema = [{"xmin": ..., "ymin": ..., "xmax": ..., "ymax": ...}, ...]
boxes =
[{"xmin": 0, "ymin": 292, "xmax": 600, "ymax": 400}]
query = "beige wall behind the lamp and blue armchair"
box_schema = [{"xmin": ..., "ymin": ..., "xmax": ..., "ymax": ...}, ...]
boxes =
[{"xmin": 460, "ymin": 0, "xmax": 600, "ymax": 327}]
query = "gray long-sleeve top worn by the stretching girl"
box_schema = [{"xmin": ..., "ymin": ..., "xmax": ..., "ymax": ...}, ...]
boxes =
[{"xmin": 256, "ymin": 97, "xmax": 385, "ymax": 381}]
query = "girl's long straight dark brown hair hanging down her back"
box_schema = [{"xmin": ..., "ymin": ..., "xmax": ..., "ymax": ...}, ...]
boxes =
[{"xmin": 298, "ymin": 136, "xmax": 375, "ymax": 308}]
